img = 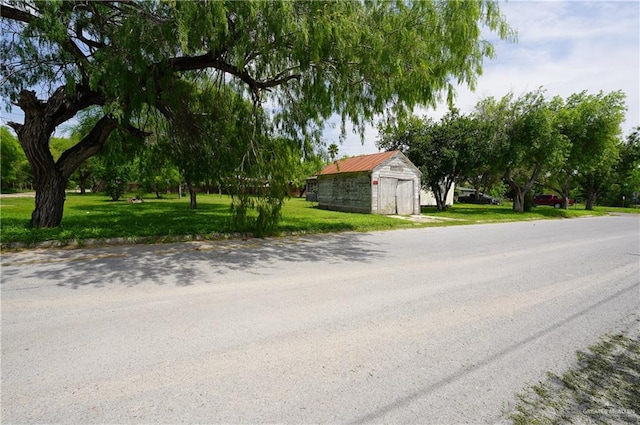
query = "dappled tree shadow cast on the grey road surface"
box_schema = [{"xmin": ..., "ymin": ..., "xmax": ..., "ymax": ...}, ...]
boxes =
[{"xmin": 3, "ymin": 233, "xmax": 383, "ymax": 290}]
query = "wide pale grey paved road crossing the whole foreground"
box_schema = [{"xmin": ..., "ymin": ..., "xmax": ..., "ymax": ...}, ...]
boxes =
[{"xmin": 1, "ymin": 216, "xmax": 640, "ymax": 424}]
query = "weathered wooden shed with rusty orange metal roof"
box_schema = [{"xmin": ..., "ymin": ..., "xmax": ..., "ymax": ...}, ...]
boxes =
[{"xmin": 317, "ymin": 151, "xmax": 422, "ymax": 215}]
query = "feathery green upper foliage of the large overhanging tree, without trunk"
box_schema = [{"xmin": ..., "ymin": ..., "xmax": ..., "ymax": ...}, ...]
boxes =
[{"xmin": 1, "ymin": 1, "xmax": 515, "ymax": 132}]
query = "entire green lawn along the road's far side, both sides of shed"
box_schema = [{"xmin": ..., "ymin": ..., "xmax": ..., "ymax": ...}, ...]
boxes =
[{"xmin": 0, "ymin": 193, "xmax": 639, "ymax": 248}]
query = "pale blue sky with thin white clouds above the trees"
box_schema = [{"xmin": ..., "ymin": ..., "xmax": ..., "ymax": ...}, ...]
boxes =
[{"xmin": 324, "ymin": 0, "xmax": 640, "ymax": 156}]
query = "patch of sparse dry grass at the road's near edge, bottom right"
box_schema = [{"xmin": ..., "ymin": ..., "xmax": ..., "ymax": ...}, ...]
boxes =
[{"xmin": 507, "ymin": 314, "xmax": 640, "ymax": 425}]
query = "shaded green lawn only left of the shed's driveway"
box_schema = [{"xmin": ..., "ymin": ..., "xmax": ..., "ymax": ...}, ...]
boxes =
[{"xmin": 0, "ymin": 194, "xmax": 414, "ymax": 246}]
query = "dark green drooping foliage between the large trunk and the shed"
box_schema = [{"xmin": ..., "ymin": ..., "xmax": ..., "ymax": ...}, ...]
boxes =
[{"xmin": 158, "ymin": 78, "xmax": 300, "ymax": 222}]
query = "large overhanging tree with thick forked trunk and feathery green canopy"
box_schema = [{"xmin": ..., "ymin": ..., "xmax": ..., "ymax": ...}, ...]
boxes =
[{"xmin": 0, "ymin": 0, "xmax": 512, "ymax": 227}]
